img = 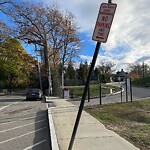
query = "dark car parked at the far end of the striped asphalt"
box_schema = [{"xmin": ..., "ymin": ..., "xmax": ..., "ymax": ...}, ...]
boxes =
[{"xmin": 26, "ymin": 89, "xmax": 43, "ymax": 100}]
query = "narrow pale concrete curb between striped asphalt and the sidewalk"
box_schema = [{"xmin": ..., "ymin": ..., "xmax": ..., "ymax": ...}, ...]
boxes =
[{"xmin": 46, "ymin": 101, "xmax": 59, "ymax": 150}]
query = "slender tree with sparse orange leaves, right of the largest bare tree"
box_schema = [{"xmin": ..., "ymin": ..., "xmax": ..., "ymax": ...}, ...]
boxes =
[{"xmin": 60, "ymin": 12, "xmax": 80, "ymax": 95}]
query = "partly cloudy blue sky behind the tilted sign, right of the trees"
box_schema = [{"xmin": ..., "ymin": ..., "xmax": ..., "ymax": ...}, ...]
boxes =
[{"xmin": 0, "ymin": 0, "xmax": 150, "ymax": 71}]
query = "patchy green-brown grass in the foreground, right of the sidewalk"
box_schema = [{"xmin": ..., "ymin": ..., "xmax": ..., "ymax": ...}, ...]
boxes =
[{"xmin": 85, "ymin": 99, "xmax": 150, "ymax": 150}]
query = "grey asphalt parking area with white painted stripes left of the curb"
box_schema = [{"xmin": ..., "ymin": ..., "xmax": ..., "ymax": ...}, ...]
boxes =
[{"xmin": 0, "ymin": 96, "xmax": 51, "ymax": 150}]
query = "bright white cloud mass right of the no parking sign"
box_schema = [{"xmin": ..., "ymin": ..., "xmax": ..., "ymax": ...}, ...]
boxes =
[{"xmin": 105, "ymin": 0, "xmax": 150, "ymax": 68}]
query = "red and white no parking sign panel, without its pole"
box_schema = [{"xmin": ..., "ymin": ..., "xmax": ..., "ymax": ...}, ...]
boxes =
[{"xmin": 92, "ymin": 3, "xmax": 117, "ymax": 43}]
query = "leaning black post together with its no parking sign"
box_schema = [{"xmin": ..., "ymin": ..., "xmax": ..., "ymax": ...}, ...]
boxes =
[{"xmin": 68, "ymin": 0, "xmax": 117, "ymax": 150}]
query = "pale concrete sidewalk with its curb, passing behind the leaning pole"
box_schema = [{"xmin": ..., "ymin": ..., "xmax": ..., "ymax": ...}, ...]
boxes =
[{"xmin": 46, "ymin": 97, "xmax": 138, "ymax": 150}]
